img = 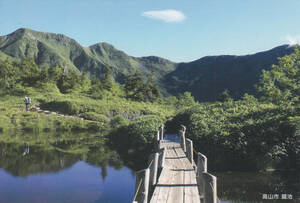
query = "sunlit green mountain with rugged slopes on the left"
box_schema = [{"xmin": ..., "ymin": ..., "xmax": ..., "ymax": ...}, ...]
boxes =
[{"xmin": 0, "ymin": 28, "xmax": 176, "ymax": 82}]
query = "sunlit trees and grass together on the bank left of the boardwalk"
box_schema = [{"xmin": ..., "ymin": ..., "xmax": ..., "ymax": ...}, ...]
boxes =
[{"xmin": 0, "ymin": 56, "xmax": 181, "ymax": 132}]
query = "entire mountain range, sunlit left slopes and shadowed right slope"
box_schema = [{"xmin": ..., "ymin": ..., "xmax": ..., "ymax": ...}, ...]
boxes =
[{"xmin": 0, "ymin": 28, "xmax": 293, "ymax": 101}]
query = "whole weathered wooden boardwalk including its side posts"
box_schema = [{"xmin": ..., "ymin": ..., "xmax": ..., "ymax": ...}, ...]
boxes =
[{"xmin": 132, "ymin": 126, "xmax": 217, "ymax": 203}]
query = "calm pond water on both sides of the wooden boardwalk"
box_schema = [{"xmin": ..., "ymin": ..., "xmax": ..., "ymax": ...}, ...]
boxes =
[{"xmin": 0, "ymin": 133, "xmax": 300, "ymax": 203}]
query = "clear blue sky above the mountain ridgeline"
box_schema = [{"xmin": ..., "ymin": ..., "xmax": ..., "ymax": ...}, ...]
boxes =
[{"xmin": 0, "ymin": 0, "xmax": 300, "ymax": 62}]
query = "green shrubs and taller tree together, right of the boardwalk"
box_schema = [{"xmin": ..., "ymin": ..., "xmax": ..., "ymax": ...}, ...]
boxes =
[{"xmin": 168, "ymin": 49, "xmax": 300, "ymax": 170}]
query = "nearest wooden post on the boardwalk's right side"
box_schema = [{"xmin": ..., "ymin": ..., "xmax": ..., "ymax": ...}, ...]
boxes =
[{"xmin": 202, "ymin": 172, "xmax": 217, "ymax": 203}]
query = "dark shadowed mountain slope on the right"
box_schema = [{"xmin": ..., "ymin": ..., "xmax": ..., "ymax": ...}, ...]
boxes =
[{"xmin": 164, "ymin": 45, "xmax": 294, "ymax": 101}]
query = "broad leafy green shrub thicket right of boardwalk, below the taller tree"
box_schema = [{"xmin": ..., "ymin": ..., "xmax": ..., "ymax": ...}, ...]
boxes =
[{"xmin": 167, "ymin": 99, "xmax": 299, "ymax": 170}]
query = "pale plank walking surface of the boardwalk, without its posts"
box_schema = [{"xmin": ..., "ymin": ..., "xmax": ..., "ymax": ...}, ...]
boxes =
[{"xmin": 150, "ymin": 142, "xmax": 200, "ymax": 203}]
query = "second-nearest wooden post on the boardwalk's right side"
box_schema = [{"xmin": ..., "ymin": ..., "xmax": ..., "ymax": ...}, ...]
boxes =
[{"xmin": 197, "ymin": 152, "xmax": 207, "ymax": 202}]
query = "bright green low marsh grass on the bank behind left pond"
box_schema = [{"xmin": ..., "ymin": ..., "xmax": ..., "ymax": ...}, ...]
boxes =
[{"xmin": 0, "ymin": 83, "xmax": 175, "ymax": 133}]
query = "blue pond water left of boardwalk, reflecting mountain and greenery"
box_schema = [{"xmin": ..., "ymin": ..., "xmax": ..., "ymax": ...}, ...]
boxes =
[{"xmin": 0, "ymin": 134, "xmax": 135, "ymax": 203}]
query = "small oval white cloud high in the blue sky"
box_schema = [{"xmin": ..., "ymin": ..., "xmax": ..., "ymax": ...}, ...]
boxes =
[{"xmin": 142, "ymin": 9, "xmax": 186, "ymax": 23}]
